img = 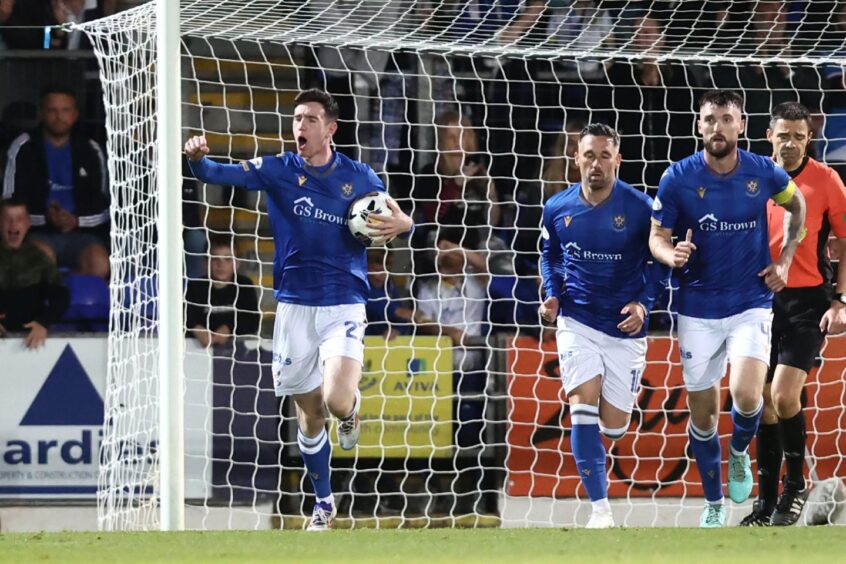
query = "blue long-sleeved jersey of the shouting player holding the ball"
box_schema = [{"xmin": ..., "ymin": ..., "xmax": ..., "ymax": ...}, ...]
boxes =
[{"xmin": 190, "ymin": 152, "xmax": 385, "ymax": 306}]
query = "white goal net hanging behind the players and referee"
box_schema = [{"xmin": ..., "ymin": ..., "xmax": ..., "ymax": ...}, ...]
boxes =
[{"xmin": 82, "ymin": 0, "xmax": 846, "ymax": 529}]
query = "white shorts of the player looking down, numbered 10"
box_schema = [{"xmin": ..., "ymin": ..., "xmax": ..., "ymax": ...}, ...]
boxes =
[{"xmin": 555, "ymin": 316, "xmax": 646, "ymax": 413}]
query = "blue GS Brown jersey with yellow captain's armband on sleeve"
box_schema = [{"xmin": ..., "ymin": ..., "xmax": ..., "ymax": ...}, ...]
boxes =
[{"xmin": 652, "ymin": 150, "xmax": 796, "ymax": 319}]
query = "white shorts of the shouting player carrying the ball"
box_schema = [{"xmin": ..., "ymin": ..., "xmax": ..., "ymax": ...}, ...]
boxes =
[{"xmin": 272, "ymin": 303, "xmax": 366, "ymax": 397}]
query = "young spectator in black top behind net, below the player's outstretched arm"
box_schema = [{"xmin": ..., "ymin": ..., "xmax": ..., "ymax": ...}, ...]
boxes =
[{"xmin": 185, "ymin": 238, "xmax": 261, "ymax": 347}]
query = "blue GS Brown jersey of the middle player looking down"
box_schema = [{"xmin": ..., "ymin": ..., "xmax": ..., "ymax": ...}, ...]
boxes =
[{"xmin": 541, "ymin": 180, "xmax": 669, "ymax": 338}]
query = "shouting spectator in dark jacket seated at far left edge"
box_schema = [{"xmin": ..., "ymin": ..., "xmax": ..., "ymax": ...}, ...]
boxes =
[{"xmin": 0, "ymin": 199, "xmax": 68, "ymax": 349}]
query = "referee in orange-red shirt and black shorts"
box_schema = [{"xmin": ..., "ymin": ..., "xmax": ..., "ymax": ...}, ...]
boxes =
[{"xmin": 740, "ymin": 102, "xmax": 846, "ymax": 527}]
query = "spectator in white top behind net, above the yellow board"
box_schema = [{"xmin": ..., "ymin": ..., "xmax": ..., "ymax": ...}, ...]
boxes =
[{"xmin": 414, "ymin": 239, "xmax": 488, "ymax": 373}]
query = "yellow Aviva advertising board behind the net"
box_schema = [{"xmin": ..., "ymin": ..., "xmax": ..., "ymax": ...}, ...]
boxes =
[{"xmin": 330, "ymin": 337, "xmax": 453, "ymax": 458}]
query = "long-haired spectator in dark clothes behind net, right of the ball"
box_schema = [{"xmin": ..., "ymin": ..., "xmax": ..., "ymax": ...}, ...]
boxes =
[{"xmin": 412, "ymin": 111, "xmax": 514, "ymax": 274}]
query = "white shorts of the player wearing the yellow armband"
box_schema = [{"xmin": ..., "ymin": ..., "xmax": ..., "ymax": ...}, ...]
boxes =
[{"xmin": 679, "ymin": 308, "xmax": 773, "ymax": 392}]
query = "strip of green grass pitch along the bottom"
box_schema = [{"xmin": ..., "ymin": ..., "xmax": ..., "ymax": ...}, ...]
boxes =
[{"xmin": 0, "ymin": 527, "xmax": 846, "ymax": 564}]
